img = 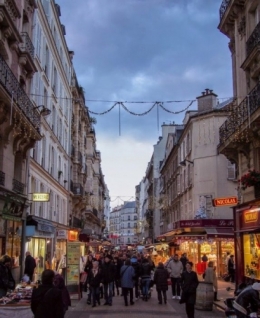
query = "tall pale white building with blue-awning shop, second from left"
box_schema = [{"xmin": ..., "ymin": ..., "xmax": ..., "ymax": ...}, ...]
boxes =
[{"xmin": 26, "ymin": 1, "xmax": 72, "ymax": 274}]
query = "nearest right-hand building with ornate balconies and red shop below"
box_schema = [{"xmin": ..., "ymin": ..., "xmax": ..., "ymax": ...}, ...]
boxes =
[{"xmin": 218, "ymin": 0, "xmax": 260, "ymax": 283}]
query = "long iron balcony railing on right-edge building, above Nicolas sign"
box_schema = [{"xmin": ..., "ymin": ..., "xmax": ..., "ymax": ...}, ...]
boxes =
[{"xmin": 219, "ymin": 81, "xmax": 260, "ymax": 145}]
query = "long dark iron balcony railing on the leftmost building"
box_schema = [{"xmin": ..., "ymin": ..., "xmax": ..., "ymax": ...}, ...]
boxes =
[{"xmin": 0, "ymin": 55, "xmax": 41, "ymax": 132}]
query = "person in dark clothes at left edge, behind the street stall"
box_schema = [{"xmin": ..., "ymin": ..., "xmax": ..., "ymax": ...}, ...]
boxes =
[{"xmin": 0, "ymin": 255, "xmax": 15, "ymax": 298}]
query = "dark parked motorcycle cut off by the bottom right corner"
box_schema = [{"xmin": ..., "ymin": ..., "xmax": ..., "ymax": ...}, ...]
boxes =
[{"xmin": 233, "ymin": 283, "xmax": 260, "ymax": 318}]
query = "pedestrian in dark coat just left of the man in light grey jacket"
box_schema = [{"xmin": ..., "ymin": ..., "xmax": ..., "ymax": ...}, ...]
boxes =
[{"xmin": 154, "ymin": 262, "xmax": 169, "ymax": 305}]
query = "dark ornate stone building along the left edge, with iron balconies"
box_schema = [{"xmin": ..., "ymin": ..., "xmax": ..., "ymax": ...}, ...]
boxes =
[{"xmin": 0, "ymin": 0, "xmax": 42, "ymax": 278}]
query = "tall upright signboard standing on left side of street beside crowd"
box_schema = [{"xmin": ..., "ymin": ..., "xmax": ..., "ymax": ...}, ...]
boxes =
[{"xmin": 66, "ymin": 242, "xmax": 81, "ymax": 294}]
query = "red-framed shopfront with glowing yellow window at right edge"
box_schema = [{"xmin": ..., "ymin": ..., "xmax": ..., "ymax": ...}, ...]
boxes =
[{"xmin": 233, "ymin": 201, "xmax": 260, "ymax": 284}]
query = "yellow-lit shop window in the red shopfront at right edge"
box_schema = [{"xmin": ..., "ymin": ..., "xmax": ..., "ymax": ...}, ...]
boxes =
[{"xmin": 243, "ymin": 233, "xmax": 260, "ymax": 279}]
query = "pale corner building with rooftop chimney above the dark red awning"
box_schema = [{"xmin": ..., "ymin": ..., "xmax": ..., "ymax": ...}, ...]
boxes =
[{"xmin": 159, "ymin": 89, "xmax": 237, "ymax": 274}]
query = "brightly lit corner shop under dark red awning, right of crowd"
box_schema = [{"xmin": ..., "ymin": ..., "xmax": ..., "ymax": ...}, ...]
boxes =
[{"xmin": 169, "ymin": 219, "xmax": 234, "ymax": 276}]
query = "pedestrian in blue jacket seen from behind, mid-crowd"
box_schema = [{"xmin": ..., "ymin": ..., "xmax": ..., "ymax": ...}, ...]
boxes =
[{"xmin": 120, "ymin": 259, "xmax": 135, "ymax": 306}]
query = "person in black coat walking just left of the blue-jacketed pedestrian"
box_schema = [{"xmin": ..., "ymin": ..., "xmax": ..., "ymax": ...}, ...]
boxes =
[{"xmin": 101, "ymin": 255, "xmax": 115, "ymax": 306}]
